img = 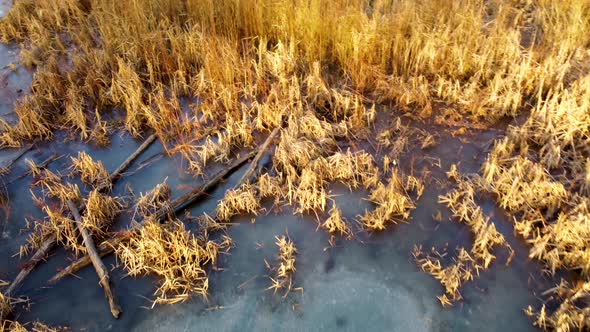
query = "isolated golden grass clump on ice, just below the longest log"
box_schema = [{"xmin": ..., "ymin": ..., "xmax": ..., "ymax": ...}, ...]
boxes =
[{"xmin": 116, "ymin": 220, "xmax": 220, "ymax": 305}]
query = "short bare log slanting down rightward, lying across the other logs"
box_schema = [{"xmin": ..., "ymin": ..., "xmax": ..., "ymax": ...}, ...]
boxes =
[{"xmin": 68, "ymin": 200, "xmax": 121, "ymax": 318}]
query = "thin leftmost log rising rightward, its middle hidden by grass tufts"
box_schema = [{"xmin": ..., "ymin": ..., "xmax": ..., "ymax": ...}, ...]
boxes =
[{"xmin": 0, "ymin": 134, "xmax": 156, "ymax": 312}]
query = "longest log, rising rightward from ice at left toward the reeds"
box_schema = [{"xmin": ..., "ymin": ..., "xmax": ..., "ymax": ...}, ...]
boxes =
[{"xmin": 49, "ymin": 150, "xmax": 259, "ymax": 283}]
